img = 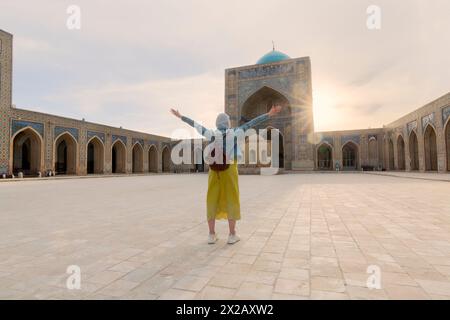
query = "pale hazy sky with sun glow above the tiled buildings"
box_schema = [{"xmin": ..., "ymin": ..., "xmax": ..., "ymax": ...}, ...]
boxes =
[{"xmin": 0, "ymin": 0, "xmax": 450, "ymax": 136}]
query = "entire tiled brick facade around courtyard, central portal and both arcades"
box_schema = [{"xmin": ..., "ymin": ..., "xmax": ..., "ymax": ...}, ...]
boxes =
[{"xmin": 0, "ymin": 30, "xmax": 450, "ymax": 175}]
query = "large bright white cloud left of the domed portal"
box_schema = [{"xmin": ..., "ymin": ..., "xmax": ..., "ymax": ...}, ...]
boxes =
[{"xmin": 46, "ymin": 74, "xmax": 224, "ymax": 136}]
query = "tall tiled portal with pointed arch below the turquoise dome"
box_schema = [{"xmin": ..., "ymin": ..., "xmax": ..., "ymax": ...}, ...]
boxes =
[{"xmin": 225, "ymin": 57, "xmax": 314, "ymax": 170}]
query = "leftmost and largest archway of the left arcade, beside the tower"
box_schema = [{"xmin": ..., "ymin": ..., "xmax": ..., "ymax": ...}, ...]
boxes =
[{"xmin": 10, "ymin": 127, "xmax": 44, "ymax": 176}]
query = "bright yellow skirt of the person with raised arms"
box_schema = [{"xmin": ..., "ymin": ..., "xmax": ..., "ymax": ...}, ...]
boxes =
[{"xmin": 206, "ymin": 163, "xmax": 241, "ymax": 220}]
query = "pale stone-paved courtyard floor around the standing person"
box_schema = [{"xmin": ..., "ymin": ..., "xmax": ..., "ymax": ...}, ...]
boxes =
[{"xmin": 0, "ymin": 173, "xmax": 450, "ymax": 299}]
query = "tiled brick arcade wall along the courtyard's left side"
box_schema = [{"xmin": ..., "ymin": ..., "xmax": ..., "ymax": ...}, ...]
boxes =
[{"xmin": 0, "ymin": 31, "xmax": 178, "ymax": 175}]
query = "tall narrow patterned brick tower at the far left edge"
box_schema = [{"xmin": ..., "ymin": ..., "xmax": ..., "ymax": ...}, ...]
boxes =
[{"xmin": 0, "ymin": 30, "xmax": 13, "ymax": 178}]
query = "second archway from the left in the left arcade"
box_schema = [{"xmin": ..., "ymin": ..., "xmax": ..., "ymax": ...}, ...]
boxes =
[{"xmin": 53, "ymin": 131, "xmax": 78, "ymax": 174}]
